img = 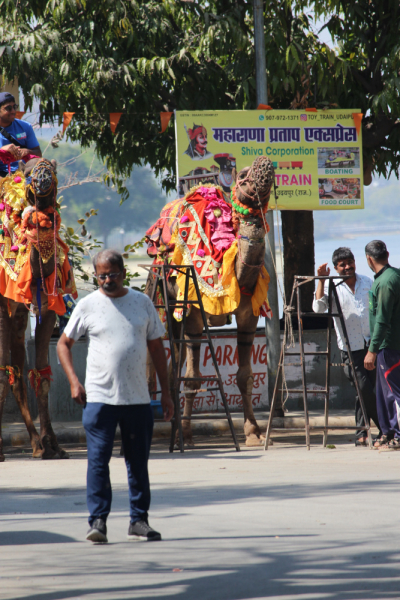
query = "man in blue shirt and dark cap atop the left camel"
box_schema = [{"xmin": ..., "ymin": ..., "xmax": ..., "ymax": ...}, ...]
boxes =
[{"xmin": 0, "ymin": 92, "xmax": 42, "ymax": 177}]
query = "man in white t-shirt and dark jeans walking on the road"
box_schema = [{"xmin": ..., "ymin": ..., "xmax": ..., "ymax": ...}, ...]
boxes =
[{"xmin": 57, "ymin": 250, "xmax": 174, "ymax": 543}]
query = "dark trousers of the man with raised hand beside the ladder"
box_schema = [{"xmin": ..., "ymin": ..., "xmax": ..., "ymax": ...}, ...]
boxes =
[{"xmin": 342, "ymin": 348, "xmax": 381, "ymax": 439}]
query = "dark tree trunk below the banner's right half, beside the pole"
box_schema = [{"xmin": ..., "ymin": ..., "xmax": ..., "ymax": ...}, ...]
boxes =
[{"xmin": 281, "ymin": 210, "xmax": 315, "ymax": 311}]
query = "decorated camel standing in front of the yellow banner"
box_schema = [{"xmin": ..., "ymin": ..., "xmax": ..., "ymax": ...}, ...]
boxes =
[{"xmin": 146, "ymin": 157, "xmax": 274, "ymax": 446}]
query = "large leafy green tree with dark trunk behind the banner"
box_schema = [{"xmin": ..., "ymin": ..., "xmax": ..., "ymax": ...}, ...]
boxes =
[{"xmin": 0, "ymin": 0, "xmax": 400, "ymax": 310}]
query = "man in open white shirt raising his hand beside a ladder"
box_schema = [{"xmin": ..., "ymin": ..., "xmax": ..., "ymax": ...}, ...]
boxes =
[{"xmin": 312, "ymin": 248, "xmax": 381, "ymax": 446}]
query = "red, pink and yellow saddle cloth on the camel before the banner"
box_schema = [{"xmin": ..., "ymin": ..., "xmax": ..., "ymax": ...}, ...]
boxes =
[{"xmin": 145, "ymin": 185, "xmax": 270, "ymax": 320}]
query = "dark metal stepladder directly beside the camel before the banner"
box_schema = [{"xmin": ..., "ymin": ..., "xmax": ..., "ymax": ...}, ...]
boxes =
[{"xmin": 138, "ymin": 264, "xmax": 240, "ymax": 452}]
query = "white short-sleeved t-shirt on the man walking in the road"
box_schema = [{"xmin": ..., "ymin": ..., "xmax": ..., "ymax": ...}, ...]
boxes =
[{"xmin": 64, "ymin": 289, "xmax": 164, "ymax": 405}]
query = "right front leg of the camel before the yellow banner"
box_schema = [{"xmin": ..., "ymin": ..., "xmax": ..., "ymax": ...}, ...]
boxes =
[{"xmin": 235, "ymin": 296, "xmax": 264, "ymax": 446}]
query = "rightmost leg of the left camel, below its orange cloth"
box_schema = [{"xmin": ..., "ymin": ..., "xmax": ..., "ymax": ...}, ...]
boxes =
[{"xmin": 35, "ymin": 310, "xmax": 69, "ymax": 459}]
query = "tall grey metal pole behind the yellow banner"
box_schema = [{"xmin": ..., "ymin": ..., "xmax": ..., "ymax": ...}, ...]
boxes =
[{"xmin": 253, "ymin": 0, "xmax": 283, "ymax": 416}]
